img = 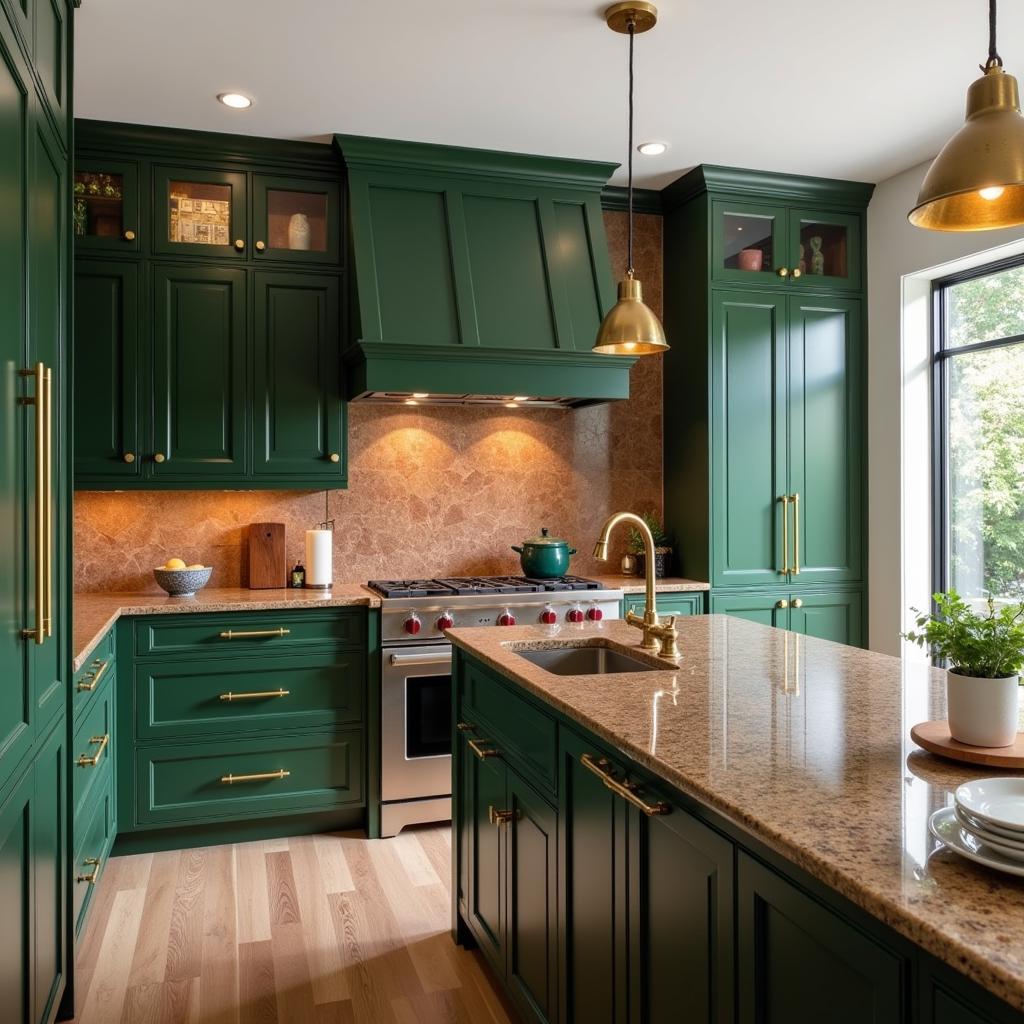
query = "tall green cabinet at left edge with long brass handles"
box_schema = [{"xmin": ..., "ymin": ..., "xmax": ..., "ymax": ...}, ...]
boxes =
[{"xmin": 0, "ymin": 0, "xmax": 77, "ymax": 1024}]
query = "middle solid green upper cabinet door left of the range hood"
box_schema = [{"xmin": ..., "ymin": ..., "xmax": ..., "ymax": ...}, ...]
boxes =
[{"xmin": 150, "ymin": 260, "xmax": 247, "ymax": 482}]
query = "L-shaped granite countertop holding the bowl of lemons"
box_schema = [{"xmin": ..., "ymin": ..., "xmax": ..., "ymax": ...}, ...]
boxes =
[{"xmin": 72, "ymin": 583, "xmax": 381, "ymax": 672}]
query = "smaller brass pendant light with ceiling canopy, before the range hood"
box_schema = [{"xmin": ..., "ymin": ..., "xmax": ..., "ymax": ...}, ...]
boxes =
[{"xmin": 594, "ymin": 0, "xmax": 669, "ymax": 355}]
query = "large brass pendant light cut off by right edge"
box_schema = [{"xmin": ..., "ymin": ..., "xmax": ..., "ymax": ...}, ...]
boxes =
[{"xmin": 908, "ymin": 0, "xmax": 1024, "ymax": 231}]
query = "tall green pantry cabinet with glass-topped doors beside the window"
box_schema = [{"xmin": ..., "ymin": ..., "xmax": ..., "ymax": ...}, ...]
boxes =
[{"xmin": 663, "ymin": 165, "xmax": 872, "ymax": 646}]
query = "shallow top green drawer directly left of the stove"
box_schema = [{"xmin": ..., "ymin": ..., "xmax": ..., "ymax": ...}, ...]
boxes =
[{"xmin": 135, "ymin": 608, "xmax": 366, "ymax": 657}]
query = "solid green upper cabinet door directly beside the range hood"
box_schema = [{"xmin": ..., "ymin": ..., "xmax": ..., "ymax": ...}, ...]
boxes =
[{"xmin": 252, "ymin": 272, "xmax": 346, "ymax": 486}]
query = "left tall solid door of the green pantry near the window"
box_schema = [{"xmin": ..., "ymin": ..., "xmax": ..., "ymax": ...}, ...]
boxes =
[{"xmin": 711, "ymin": 291, "xmax": 786, "ymax": 587}]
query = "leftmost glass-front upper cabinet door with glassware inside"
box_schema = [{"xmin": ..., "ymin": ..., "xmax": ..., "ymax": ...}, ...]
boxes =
[{"xmin": 72, "ymin": 159, "xmax": 140, "ymax": 252}]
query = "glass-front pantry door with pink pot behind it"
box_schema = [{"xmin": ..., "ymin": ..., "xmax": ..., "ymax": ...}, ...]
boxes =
[{"xmin": 712, "ymin": 200, "xmax": 788, "ymax": 284}]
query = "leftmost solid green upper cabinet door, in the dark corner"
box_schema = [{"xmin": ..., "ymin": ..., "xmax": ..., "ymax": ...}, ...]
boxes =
[{"xmin": 75, "ymin": 259, "xmax": 140, "ymax": 475}]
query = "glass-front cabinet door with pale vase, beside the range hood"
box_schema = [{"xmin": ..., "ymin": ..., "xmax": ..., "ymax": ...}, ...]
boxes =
[{"xmin": 253, "ymin": 174, "xmax": 341, "ymax": 263}]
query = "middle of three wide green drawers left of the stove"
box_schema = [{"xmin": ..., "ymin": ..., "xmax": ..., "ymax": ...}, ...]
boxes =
[{"xmin": 135, "ymin": 651, "xmax": 366, "ymax": 741}]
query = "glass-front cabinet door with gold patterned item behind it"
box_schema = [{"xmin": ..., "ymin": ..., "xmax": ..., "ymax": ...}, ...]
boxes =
[{"xmin": 153, "ymin": 167, "xmax": 249, "ymax": 259}]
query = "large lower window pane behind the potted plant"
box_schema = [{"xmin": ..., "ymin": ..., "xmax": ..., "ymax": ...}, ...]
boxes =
[{"xmin": 946, "ymin": 344, "xmax": 1024, "ymax": 600}]
